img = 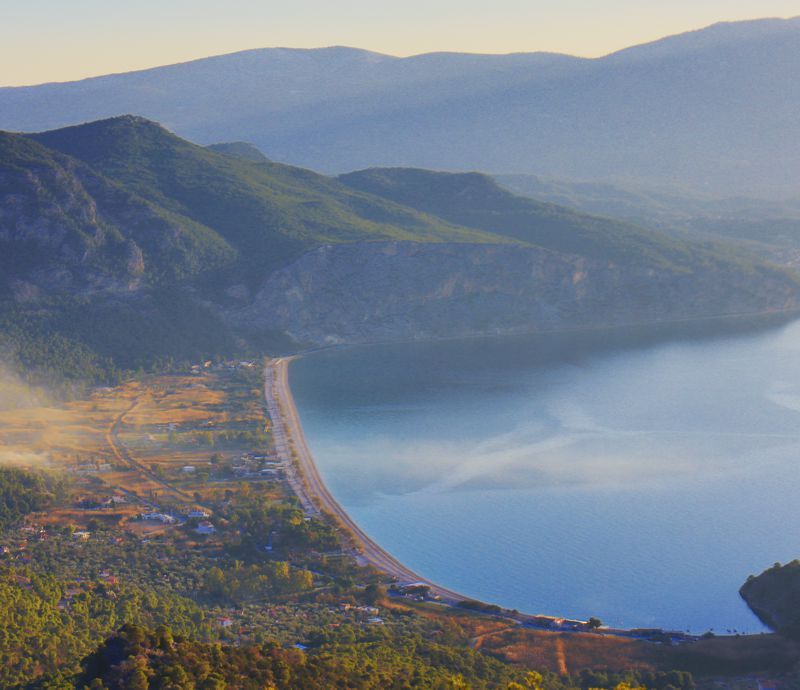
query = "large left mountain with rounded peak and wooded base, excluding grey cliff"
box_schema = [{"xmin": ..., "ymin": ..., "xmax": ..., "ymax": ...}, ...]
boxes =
[{"xmin": 0, "ymin": 117, "xmax": 496, "ymax": 389}]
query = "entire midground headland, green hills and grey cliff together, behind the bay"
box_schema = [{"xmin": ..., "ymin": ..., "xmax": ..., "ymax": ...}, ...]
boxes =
[{"xmin": 0, "ymin": 116, "xmax": 800, "ymax": 378}]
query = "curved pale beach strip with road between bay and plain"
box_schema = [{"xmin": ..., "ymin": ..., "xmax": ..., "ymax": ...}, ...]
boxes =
[{"xmin": 264, "ymin": 357, "xmax": 467, "ymax": 603}]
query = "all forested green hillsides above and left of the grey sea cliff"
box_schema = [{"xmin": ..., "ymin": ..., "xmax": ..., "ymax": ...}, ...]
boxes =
[{"xmin": 0, "ymin": 116, "xmax": 794, "ymax": 390}]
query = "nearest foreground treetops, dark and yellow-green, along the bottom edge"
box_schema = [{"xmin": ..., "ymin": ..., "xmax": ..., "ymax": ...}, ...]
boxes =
[{"xmin": 35, "ymin": 625, "xmax": 695, "ymax": 690}]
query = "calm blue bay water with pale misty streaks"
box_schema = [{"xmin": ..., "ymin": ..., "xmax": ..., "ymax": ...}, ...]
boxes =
[{"xmin": 290, "ymin": 322, "xmax": 800, "ymax": 632}]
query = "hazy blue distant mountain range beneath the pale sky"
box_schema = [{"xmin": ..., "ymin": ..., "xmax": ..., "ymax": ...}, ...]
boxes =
[{"xmin": 0, "ymin": 18, "xmax": 800, "ymax": 197}]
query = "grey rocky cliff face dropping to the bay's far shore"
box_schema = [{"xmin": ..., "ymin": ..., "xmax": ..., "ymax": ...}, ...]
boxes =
[{"xmin": 238, "ymin": 242, "xmax": 800, "ymax": 345}]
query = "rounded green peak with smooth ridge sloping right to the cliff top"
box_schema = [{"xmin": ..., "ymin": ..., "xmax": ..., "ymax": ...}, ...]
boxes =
[{"xmin": 33, "ymin": 116, "xmax": 497, "ymax": 282}]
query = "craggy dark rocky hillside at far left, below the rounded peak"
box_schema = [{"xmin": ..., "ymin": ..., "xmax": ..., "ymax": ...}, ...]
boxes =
[{"xmin": 0, "ymin": 132, "xmax": 234, "ymax": 291}]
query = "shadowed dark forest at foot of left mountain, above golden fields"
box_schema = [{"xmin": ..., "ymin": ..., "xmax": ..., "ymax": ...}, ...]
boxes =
[{"xmin": 0, "ymin": 286, "xmax": 244, "ymax": 395}]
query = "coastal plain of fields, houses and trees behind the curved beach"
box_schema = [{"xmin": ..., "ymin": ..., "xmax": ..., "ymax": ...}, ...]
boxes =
[{"xmin": 0, "ymin": 362, "xmax": 788, "ymax": 688}]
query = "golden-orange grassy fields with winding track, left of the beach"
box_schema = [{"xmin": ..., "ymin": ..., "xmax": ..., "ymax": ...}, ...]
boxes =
[{"xmin": 0, "ymin": 366, "xmax": 285, "ymax": 532}]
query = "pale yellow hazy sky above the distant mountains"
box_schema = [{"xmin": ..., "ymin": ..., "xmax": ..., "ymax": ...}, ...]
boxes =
[{"xmin": 0, "ymin": 0, "xmax": 800, "ymax": 85}]
